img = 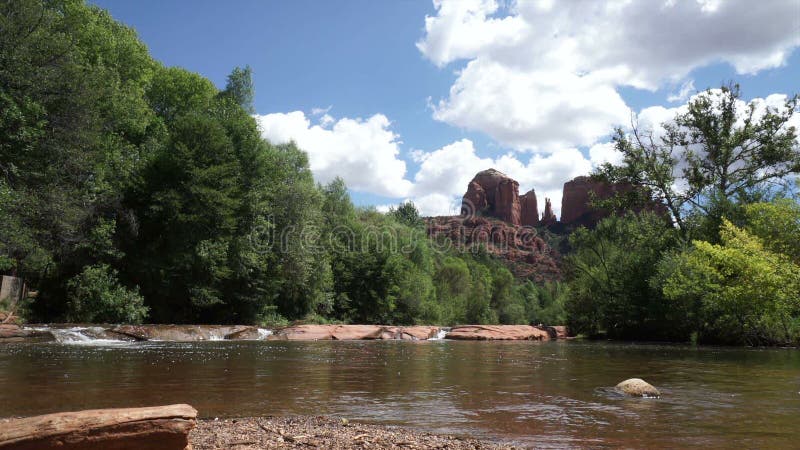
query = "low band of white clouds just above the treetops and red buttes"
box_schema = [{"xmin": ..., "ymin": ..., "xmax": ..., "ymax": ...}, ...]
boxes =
[{"xmin": 256, "ymin": 90, "xmax": 800, "ymax": 220}]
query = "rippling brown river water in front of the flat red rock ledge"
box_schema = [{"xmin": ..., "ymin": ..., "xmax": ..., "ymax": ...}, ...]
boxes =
[{"xmin": 0, "ymin": 341, "xmax": 800, "ymax": 448}]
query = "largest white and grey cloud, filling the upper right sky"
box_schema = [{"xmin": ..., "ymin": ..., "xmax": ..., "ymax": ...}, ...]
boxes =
[{"xmin": 417, "ymin": 0, "xmax": 800, "ymax": 151}]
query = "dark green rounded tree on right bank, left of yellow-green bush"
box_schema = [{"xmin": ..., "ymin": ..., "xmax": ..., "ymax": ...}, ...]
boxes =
[{"xmin": 566, "ymin": 213, "xmax": 683, "ymax": 339}]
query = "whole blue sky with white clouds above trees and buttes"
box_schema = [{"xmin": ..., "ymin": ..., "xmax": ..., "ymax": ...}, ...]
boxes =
[{"xmin": 93, "ymin": 0, "xmax": 800, "ymax": 215}]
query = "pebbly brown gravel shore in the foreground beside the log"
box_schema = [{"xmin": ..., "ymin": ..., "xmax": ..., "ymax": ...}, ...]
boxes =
[{"xmin": 189, "ymin": 416, "xmax": 520, "ymax": 450}]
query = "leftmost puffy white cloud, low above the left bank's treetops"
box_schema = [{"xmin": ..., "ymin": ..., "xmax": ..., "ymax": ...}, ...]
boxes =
[{"xmin": 256, "ymin": 111, "xmax": 411, "ymax": 197}]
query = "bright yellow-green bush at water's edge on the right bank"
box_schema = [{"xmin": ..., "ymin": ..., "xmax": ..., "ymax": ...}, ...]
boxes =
[{"xmin": 663, "ymin": 221, "xmax": 800, "ymax": 345}]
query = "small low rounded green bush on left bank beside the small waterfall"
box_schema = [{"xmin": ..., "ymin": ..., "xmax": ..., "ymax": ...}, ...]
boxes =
[{"xmin": 67, "ymin": 264, "xmax": 148, "ymax": 323}]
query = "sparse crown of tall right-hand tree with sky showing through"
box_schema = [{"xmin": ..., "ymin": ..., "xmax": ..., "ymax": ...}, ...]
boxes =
[{"xmin": 595, "ymin": 85, "xmax": 800, "ymax": 241}]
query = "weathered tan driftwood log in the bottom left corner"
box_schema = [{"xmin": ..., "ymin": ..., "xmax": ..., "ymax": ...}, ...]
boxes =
[{"xmin": 0, "ymin": 405, "xmax": 197, "ymax": 450}]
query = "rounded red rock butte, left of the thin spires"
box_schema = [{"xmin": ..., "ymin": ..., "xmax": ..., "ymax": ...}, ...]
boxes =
[{"xmin": 461, "ymin": 169, "xmax": 521, "ymax": 225}]
